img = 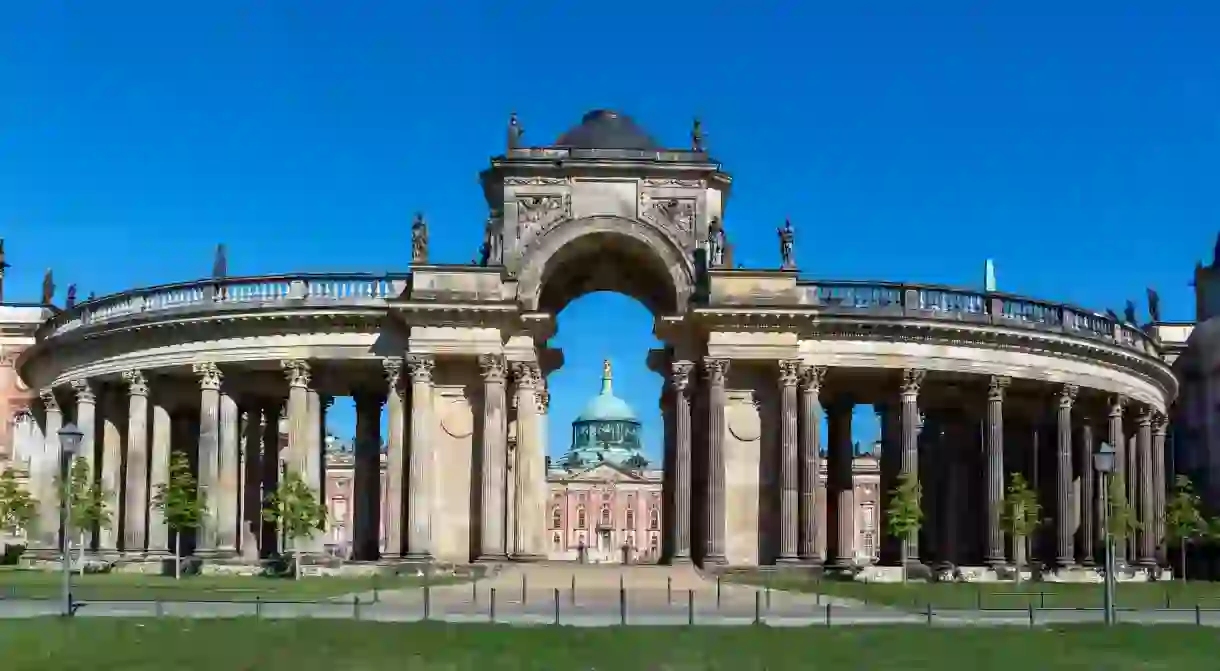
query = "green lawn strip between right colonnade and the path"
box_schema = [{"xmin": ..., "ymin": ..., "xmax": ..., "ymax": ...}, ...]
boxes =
[{"xmin": 725, "ymin": 573, "xmax": 1220, "ymax": 609}]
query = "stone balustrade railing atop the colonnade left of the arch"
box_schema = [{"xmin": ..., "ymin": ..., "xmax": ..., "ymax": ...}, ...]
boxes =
[{"xmin": 37, "ymin": 273, "xmax": 410, "ymax": 340}]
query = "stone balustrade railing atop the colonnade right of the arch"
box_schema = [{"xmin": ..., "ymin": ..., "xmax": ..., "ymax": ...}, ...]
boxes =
[{"xmin": 799, "ymin": 281, "xmax": 1160, "ymax": 357}]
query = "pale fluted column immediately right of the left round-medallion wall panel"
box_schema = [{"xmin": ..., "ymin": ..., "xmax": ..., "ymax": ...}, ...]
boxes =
[{"xmin": 478, "ymin": 354, "xmax": 508, "ymax": 561}]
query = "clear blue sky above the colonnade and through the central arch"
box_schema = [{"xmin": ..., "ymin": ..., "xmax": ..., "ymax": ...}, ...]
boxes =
[{"xmin": 0, "ymin": 0, "xmax": 1220, "ymax": 463}]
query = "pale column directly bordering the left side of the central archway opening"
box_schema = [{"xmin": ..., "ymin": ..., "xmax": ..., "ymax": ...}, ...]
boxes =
[{"xmin": 512, "ymin": 361, "xmax": 547, "ymax": 561}]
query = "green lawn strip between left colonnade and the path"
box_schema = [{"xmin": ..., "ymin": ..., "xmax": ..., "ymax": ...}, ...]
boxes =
[{"xmin": 0, "ymin": 570, "xmax": 454, "ymax": 601}]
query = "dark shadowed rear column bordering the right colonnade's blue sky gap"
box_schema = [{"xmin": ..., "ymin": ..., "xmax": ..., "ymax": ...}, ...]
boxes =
[{"xmin": 826, "ymin": 399, "xmax": 856, "ymax": 569}]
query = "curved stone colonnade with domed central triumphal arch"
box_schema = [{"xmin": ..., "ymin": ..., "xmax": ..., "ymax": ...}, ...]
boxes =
[{"xmin": 17, "ymin": 111, "xmax": 1176, "ymax": 578}]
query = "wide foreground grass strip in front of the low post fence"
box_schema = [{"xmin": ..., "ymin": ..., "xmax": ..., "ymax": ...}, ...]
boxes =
[{"xmin": 0, "ymin": 619, "xmax": 1220, "ymax": 671}]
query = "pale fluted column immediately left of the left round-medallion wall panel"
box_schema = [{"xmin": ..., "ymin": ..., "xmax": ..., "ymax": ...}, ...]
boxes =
[{"xmin": 406, "ymin": 354, "xmax": 434, "ymax": 561}]
